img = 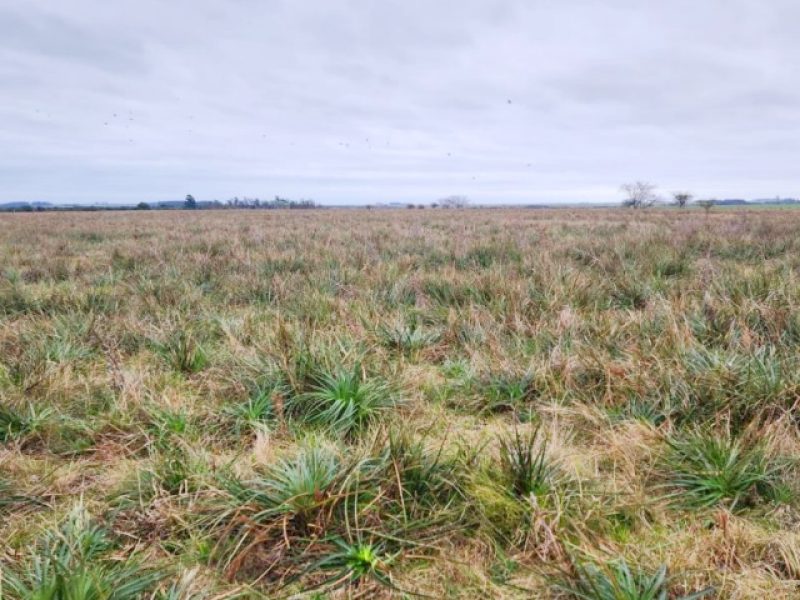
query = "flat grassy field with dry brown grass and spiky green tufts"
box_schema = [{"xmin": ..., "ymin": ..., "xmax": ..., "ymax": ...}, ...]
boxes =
[{"xmin": 0, "ymin": 209, "xmax": 800, "ymax": 600}]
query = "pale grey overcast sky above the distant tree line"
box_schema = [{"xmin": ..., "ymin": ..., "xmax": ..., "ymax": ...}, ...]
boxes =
[{"xmin": 0, "ymin": 0, "xmax": 800, "ymax": 204}]
